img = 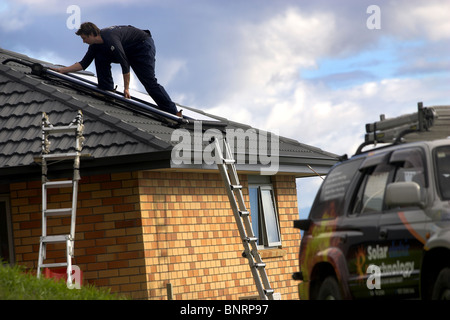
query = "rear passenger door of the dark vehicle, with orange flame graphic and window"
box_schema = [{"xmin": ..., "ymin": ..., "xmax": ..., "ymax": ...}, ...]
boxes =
[{"xmin": 343, "ymin": 153, "xmax": 394, "ymax": 299}]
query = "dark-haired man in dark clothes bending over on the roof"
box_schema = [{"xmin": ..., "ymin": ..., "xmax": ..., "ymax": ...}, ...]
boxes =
[{"xmin": 55, "ymin": 22, "xmax": 181, "ymax": 116}]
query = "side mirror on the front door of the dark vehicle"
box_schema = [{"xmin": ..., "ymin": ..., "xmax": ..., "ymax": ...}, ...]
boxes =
[{"xmin": 384, "ymin": 181, "xmax": 424, "ymax": 208}]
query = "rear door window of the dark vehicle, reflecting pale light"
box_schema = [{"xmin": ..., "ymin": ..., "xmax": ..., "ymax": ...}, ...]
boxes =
[{"xmin": 352, "ymin": 163, "xmax": 394, "ymax": 215}]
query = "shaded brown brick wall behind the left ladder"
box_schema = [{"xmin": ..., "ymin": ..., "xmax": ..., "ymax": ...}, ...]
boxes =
[{"xmin": 10, "ymin": 173, "xmax": 147, "ymax": 299}]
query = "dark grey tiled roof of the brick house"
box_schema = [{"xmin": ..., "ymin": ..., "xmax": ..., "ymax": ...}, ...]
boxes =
[{"xmin": 0, "ymin": 48, "xmax": 337, "ymax": 180}]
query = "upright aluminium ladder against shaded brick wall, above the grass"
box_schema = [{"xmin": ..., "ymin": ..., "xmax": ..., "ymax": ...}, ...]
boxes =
[{"xmin": 37, "ymin": 110, "xmax": 84, "ymax": 286}]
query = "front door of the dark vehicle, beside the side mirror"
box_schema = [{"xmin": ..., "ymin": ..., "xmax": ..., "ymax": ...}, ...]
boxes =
[{"xmin": 379, "ymin": 147, "xmax": 429, "ymax": 298}]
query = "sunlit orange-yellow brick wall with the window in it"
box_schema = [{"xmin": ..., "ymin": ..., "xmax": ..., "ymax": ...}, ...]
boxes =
[{"xmin": 140, "ymin": 172, "xmax": 300, "ymax": 299}]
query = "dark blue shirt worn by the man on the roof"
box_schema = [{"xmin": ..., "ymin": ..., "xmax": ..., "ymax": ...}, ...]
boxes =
[{"xmin": 79, "ymin": 26, "xmax": 150, "ymax": 74}]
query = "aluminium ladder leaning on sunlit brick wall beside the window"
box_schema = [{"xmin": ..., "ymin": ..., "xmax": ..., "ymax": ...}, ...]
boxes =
[{"xmin": 213, "ymin": 138, "xmax": 274, "ymax": 300}]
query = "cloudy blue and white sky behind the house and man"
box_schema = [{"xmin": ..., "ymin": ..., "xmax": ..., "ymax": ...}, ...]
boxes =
[{"xmin": 0, "ymin": 0, "xmax": 450, "ymax": 215}]
